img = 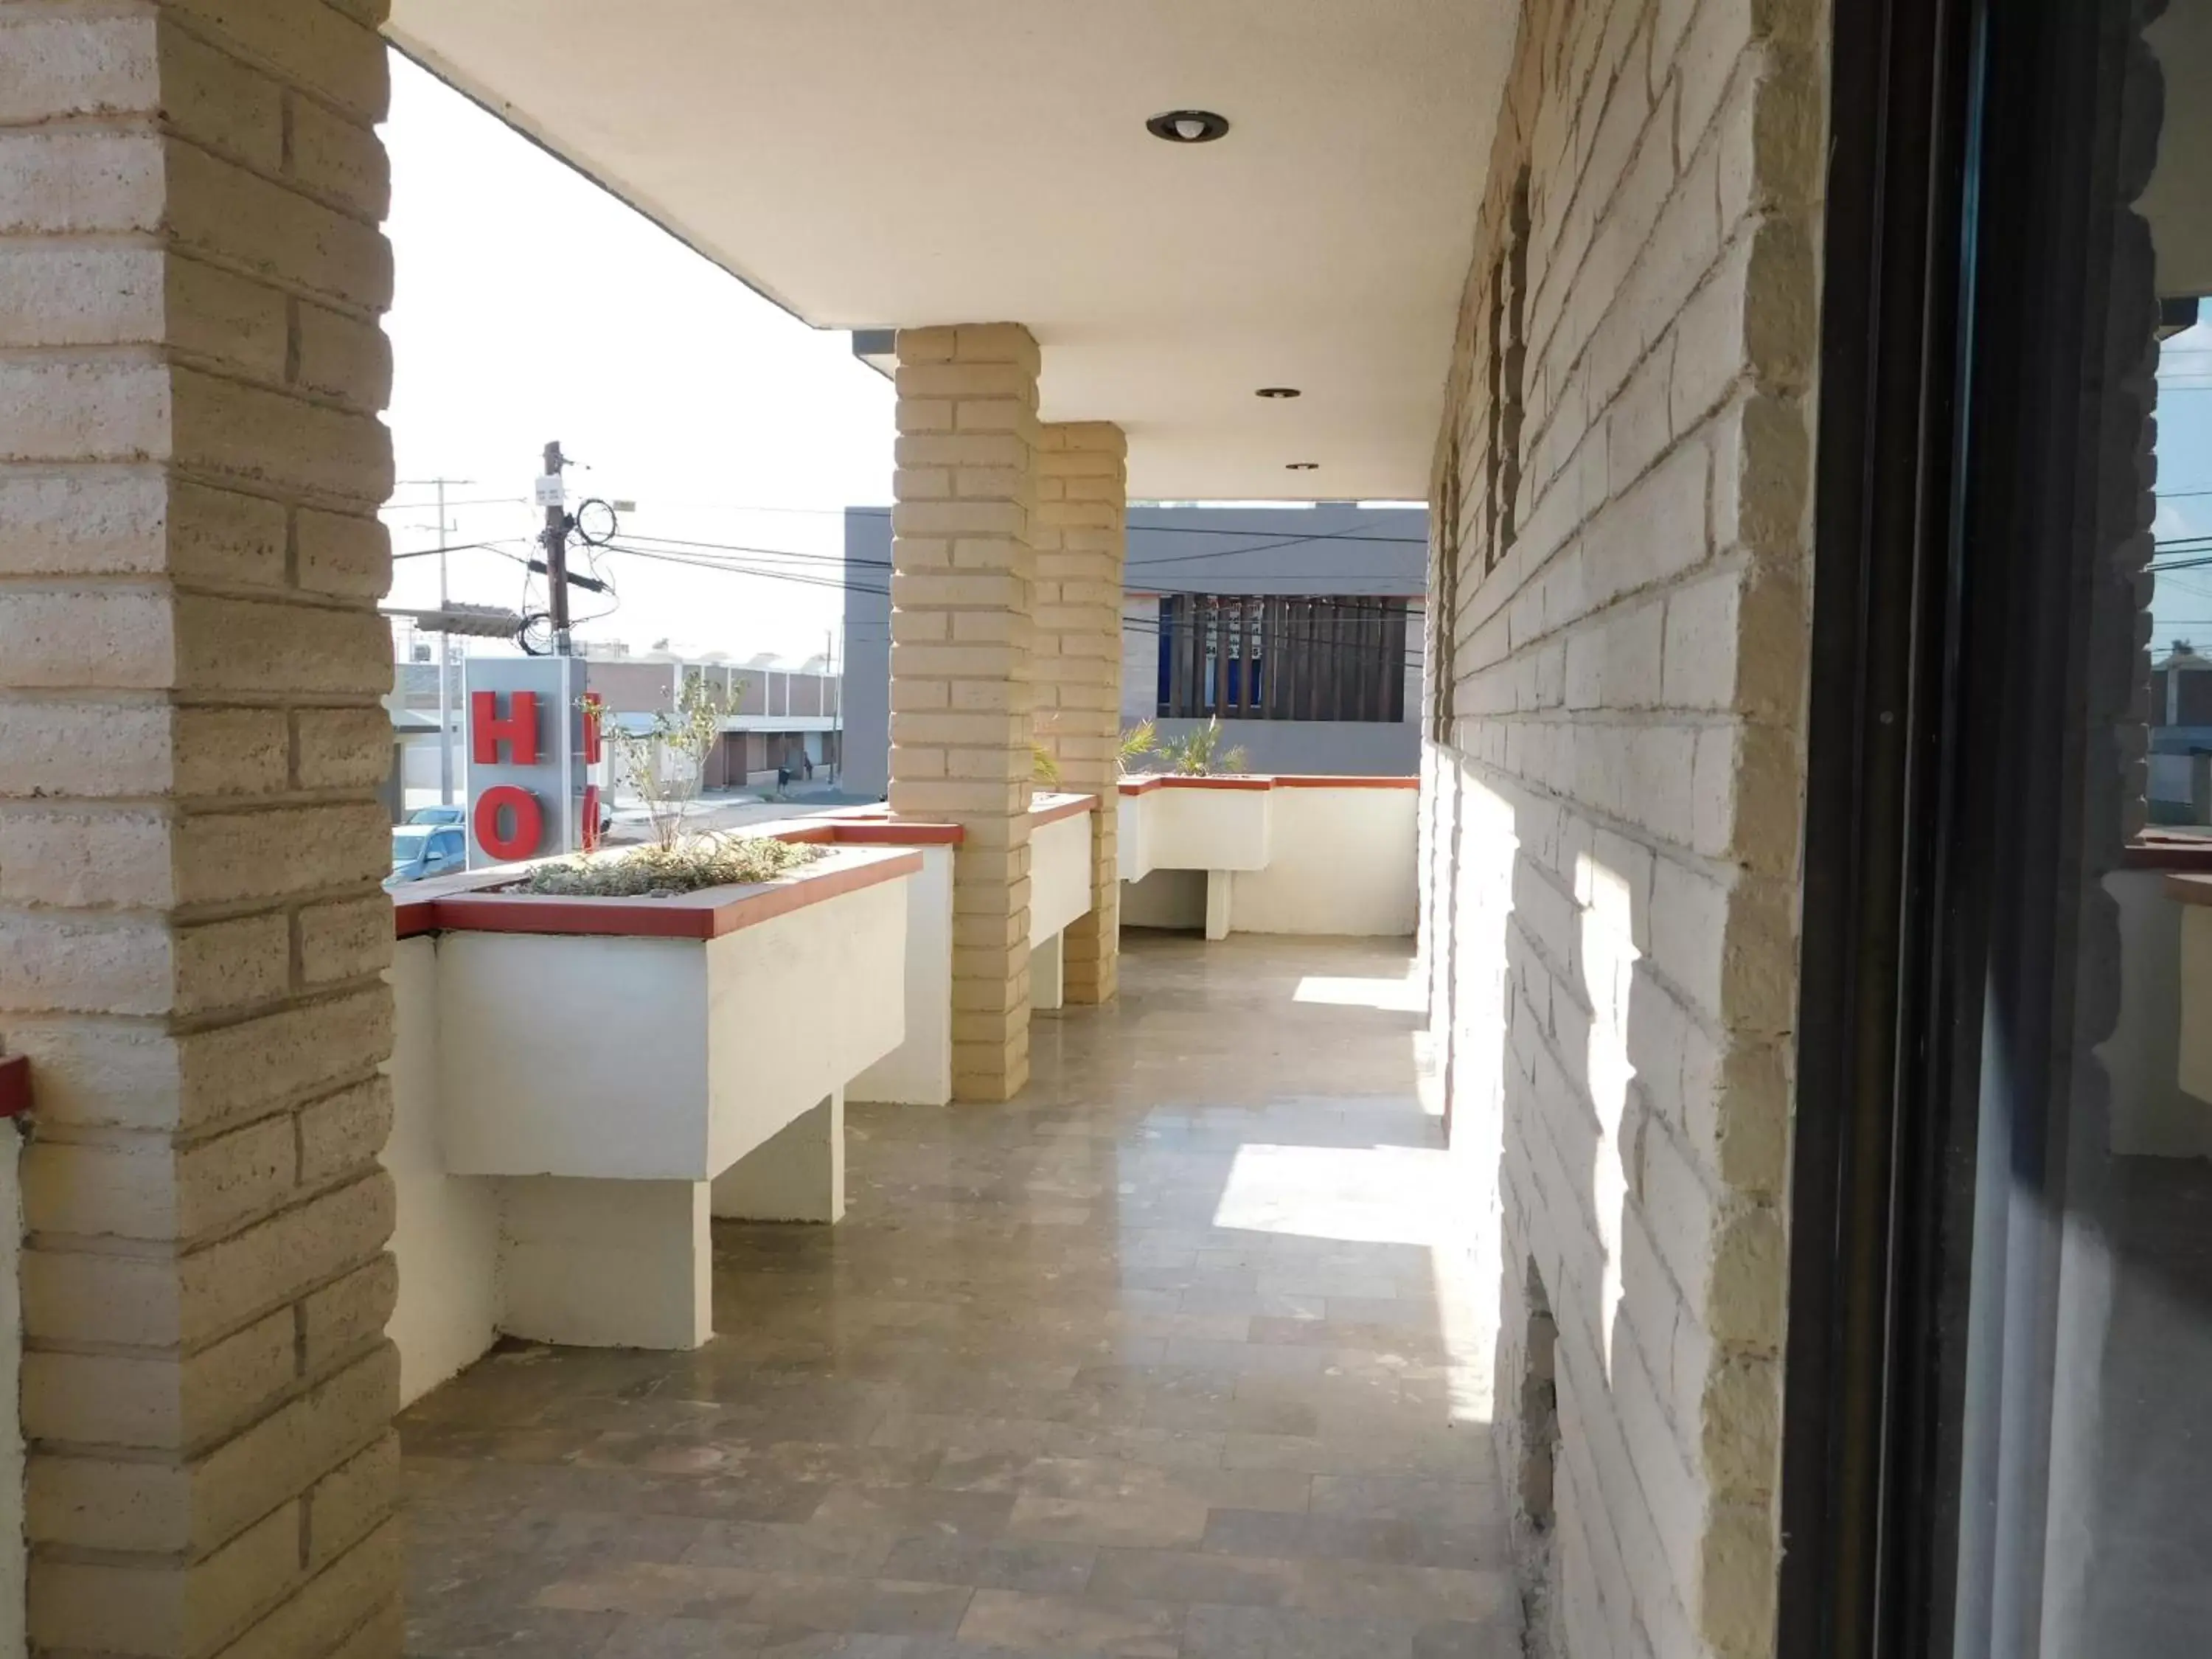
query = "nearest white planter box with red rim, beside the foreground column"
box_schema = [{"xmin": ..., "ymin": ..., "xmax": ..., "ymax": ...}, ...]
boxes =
[{"xmin": 387, "ymin": 847, "xmax": 922, "ymax": 1371}]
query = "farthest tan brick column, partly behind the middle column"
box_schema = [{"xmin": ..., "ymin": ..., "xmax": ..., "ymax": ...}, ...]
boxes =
[{"xmin": 1035, "ymin": 420, "xmax": 1128, "ymax": 1002}]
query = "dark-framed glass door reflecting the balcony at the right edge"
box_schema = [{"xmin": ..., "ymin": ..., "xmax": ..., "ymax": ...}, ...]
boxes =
[{"xmin": 1781, "ymin": 0, "xmax": 2212, "ymax": 1659}]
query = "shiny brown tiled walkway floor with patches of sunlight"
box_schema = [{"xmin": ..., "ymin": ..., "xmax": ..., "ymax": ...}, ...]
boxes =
[{"xmin": 403, "ymin": 936, "xmax": 1520, "ymax": 1659}]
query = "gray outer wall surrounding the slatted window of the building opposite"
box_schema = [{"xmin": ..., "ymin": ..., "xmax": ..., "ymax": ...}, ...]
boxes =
[{"xmin": 843, "ymin": 504, "xmax": 1429, "ymax": 794}]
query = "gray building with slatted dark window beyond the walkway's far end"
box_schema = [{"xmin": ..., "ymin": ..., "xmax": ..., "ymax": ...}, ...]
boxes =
[{"xmin": 845, "ymin": 504, "xmax": 1429, "ymax": 794}]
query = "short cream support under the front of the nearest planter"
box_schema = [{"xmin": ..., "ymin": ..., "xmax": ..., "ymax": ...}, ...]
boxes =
[{"xmin": 500, "ymin": 1175, "xmax": 714, "ymax": 1349}]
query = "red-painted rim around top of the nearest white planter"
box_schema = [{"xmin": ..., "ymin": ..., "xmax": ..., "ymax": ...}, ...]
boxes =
[{"xmin": 394, "ymin": 847, "xmax": 922, "ymax": 940}]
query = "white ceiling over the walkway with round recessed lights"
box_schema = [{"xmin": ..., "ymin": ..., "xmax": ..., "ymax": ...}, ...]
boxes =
[{"xmin": 389, "ymin": 0, "xmax": 1513, "ymax": 500}]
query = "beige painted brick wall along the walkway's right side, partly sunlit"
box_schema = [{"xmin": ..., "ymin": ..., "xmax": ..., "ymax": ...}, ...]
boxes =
[{"xmin": 1422, "ymin": 0, "xmax": 1825, "ymax": 1659}]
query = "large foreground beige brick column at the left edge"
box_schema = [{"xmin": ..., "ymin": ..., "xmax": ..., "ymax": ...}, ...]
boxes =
[{"xmin": 0, "ymin": 0, "xmax": 400, "ymax": 1659}]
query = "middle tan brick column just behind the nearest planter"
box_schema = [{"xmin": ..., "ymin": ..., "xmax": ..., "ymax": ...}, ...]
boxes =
[{"xmin": 891, "ymin": 323, "xmax": 1037, "ymax": 1099}]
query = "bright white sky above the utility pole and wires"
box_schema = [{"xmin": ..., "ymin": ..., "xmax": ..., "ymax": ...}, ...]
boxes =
[{"xmin": 383, "ymin": 53, "xmax": 894, "ymax": 659}]
